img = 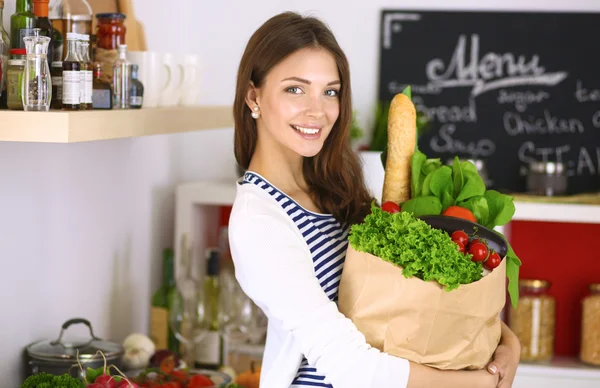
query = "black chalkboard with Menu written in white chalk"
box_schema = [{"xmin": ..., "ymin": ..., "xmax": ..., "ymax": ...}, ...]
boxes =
[{"xmin": 379, "ymin": 10, "xmax": 600, "ymax": 194}]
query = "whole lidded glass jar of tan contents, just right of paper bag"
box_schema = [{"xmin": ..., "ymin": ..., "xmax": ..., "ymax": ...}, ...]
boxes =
[{"xmin": 509, "ymin": 279, "xmax": 556, "ymax": 361}]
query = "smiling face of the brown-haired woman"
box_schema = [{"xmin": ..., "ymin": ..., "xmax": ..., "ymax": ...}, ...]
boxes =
[{"xmin": 248, "ymin": 48, "xmax": 341, "ymax": 157}]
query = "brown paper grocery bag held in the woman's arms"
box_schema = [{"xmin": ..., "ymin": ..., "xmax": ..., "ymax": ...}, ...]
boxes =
[{"xmin": 338, "ymin": 246, "xmax": 506, "ymax": 370}]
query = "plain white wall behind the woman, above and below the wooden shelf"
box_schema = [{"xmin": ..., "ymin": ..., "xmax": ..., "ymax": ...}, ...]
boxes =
[{"xmin": 0, "ymin": 0, "xmax": 600, "ymax": 388}]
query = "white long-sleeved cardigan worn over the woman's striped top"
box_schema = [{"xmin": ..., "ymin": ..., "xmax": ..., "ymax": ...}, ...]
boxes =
[{"xmin": 229, "ymin": 177, "xmax": 409, "ymax": 388}]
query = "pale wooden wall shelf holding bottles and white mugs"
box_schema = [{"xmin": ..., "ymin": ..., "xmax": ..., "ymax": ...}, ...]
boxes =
[{"xmin": 0, "ymin": 106, "xmax": 233, "ymax": 143}]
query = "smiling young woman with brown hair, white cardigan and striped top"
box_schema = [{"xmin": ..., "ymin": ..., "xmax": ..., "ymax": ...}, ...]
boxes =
[{"xmin": 229, "ymin": 13, "xmax": 519, "ymax": 388}]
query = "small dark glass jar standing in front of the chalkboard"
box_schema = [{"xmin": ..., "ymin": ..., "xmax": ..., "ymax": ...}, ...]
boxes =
[{"xmin": 527, "ymin": 162, "xmax": 567, "ymax": 196}]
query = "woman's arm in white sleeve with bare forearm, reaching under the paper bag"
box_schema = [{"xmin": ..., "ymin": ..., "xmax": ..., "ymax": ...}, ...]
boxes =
[{"xmin": 229, "ymin": 203, "xmax": 497, "ymax": 388}]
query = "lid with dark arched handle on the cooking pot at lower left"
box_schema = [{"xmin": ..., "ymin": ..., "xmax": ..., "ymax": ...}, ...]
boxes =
[{"xmin": 27, "ymin": 318, "xmax": 124, "ymax": 361}]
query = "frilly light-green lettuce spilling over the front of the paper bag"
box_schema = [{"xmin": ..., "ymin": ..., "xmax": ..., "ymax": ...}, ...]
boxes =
[{"xmin": 349, "ymin": 205, "xmax": 482, "ymax": 291}]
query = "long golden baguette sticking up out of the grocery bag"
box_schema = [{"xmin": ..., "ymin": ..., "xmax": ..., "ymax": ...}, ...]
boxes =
[{"xmin": 381, "ymin": 93, "xmax": 417, "ymax": 204}]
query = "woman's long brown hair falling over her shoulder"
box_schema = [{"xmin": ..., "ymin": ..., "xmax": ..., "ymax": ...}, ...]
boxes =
[{"xmin": 233, "ymin": 12, "xmax": 372, "ymax": 224}]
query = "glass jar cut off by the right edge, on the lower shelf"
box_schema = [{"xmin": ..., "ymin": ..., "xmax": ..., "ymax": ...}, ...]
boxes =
[{"xmin": 579, "ymin": 283, "xmax": 600, "ymax": 366}]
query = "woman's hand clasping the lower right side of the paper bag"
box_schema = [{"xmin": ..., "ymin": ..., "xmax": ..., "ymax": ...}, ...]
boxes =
[{"xmin": 487, "ymin": 322, "xmax": 521, "ymax": 388}]
